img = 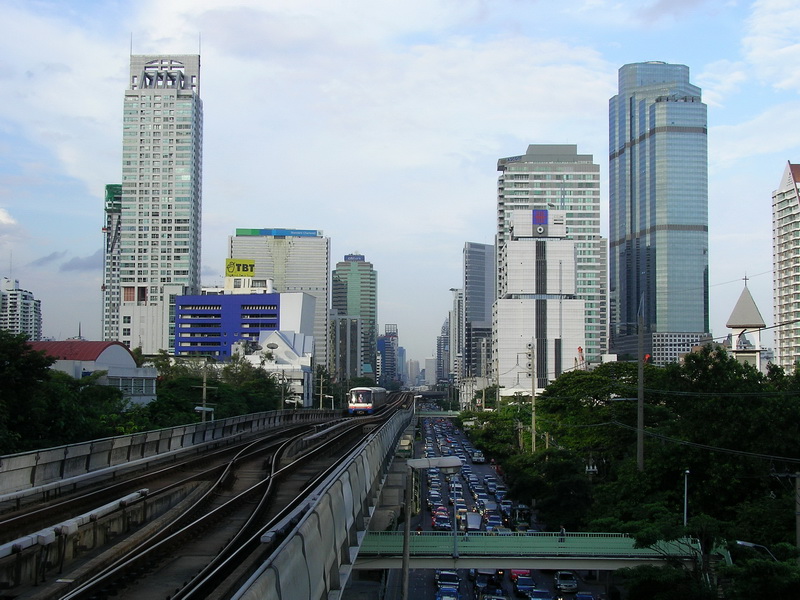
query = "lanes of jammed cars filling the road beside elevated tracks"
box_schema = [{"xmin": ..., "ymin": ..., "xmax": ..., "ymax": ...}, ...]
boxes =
[{"xmin": 414, "ymin": 418, "xmax": 602, "ymax": 600}]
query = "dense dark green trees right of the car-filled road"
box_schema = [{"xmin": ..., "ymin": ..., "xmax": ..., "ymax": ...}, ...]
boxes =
[{"xmin": 463, "ymin": 345, "xmax": 800, "ymax": 599}]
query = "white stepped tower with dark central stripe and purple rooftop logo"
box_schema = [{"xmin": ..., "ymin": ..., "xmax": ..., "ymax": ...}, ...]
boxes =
[{"xmin": 492, "ymin": 210, "xmax": 586, "ymax": 395}]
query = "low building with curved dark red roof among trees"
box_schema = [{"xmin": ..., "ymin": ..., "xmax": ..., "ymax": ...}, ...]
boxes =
[{"xmin": 29, "ymin": 340, "xmax": 158, "ymax": 404}]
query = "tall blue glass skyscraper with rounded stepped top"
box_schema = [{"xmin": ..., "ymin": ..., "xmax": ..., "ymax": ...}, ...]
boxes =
[{"xmin": 608, "ymin": 62, "xmax": 709, "ymax": 364}]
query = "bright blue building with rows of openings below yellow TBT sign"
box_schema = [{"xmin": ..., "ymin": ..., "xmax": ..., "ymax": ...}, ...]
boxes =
[{"xmin": 175, "ymin": 293, "xmax": 281, "ymax": 361}]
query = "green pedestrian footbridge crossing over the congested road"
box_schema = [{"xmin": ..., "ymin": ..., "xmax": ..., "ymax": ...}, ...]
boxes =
[{"xmin": 354, "ymin": 531, "xmax": 701, "ymax": 570}]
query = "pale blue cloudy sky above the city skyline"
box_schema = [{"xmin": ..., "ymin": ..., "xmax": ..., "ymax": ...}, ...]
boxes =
[{"xmin": 0, "ymin": 0, "xmax": 800, "ymax": 361}]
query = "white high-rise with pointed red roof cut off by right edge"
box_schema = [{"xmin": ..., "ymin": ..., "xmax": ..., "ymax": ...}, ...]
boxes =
[{"xmin": 772, "ymin": 163, "xmax": 800, "ymax": 372}]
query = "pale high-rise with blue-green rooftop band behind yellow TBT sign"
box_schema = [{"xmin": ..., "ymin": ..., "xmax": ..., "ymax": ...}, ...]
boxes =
[{"xmin": 228, "ymin": 229, "xmax": 331, "ymax": 368}]
